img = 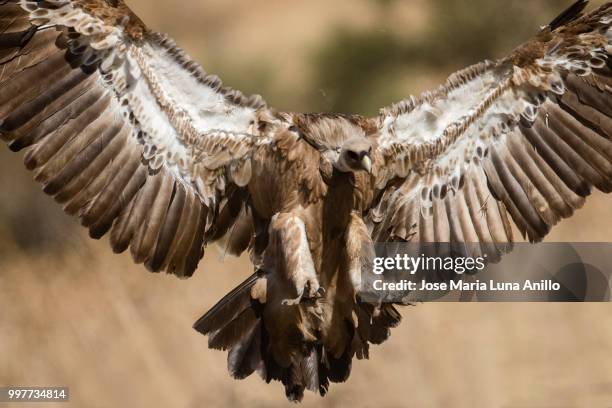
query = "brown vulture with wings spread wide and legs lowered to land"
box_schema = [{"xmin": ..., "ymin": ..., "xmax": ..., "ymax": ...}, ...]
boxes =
[{"xmin": 0, "ymin": 0, "xmax": 612, "ymax": 401}]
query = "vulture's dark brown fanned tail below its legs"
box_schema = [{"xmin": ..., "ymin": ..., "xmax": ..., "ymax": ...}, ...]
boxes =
[{"xmin": 194, "ymin": 274, "xmax": 401, "ymax": 401}]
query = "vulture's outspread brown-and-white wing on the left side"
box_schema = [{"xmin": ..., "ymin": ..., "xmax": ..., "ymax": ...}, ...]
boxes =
[{"xmin": 0, "ymin": 0, "xmax": 265, "ymax": 276}]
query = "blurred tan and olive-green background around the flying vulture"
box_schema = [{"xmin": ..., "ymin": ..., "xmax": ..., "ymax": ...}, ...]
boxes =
[{"xmin": 0, "ymin": 0, "xmax": 612, "ymax": 407}]
